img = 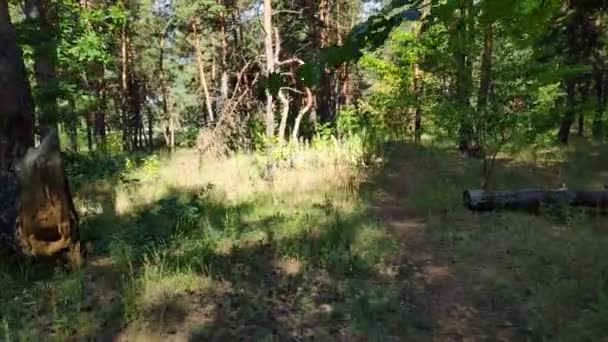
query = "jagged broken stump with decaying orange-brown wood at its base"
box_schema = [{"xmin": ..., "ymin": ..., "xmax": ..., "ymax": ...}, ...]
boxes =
[{"xmin": 16, "ymin": 130, "xmax": 81, "ymax": 265}]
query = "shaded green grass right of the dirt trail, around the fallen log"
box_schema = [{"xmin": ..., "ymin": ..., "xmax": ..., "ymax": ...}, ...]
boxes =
[{"xmin": 397, "ymin": 140, "xmax": 608, "ymax": 341}]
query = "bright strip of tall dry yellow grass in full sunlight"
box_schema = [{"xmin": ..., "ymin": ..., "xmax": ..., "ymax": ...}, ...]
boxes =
[{"xmin": 92, "ymin": 140, "xmax": 362, "ymax": 215}]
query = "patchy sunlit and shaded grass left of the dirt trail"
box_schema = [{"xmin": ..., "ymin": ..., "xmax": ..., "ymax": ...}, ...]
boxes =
[{"xmin": 0, "ymin": 138, "xmax": 397, "ymax": 341}]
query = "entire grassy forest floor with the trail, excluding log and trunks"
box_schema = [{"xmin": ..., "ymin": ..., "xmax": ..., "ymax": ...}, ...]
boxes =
[{"xmin": 0, "ymin": 143, "xmax": 608, "ymax": 342}]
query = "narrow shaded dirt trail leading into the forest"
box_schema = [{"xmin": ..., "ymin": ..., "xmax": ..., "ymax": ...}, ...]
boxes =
[{"xmin": 373, "ymin": 153, "xmax": 516, "ymax": 341}]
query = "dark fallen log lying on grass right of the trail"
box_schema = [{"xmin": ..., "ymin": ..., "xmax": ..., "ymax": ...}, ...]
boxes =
[{"xmin": 462, "ymin": 188, "xmax": 608, "ymax": 211}]
